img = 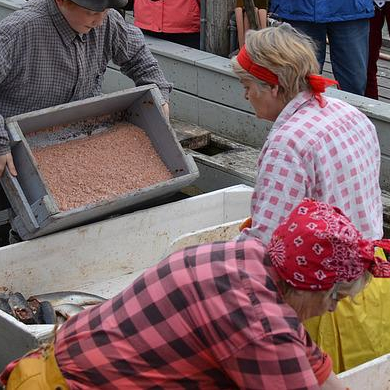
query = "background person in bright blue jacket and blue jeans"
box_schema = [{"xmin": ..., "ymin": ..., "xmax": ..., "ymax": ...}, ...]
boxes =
[{"xmin": 269, "ymin": 0, "xmax": 374, "ymax": 95}]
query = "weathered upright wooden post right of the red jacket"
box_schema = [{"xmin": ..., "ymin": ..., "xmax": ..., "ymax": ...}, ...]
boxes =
[{"xmin": 206, "ymin": 0, "xmax": 236, "ymax": 57}]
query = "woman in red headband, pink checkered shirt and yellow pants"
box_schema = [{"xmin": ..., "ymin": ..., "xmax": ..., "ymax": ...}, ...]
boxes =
[{"xmin": 232, "ymin": 23, "xmax": 390, "ymax": 371}]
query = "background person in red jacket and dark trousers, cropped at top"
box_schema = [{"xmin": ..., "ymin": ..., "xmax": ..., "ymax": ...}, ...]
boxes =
[{"xmin": 134, "ymin": 0, "xmax": 200, "ymax": 49}]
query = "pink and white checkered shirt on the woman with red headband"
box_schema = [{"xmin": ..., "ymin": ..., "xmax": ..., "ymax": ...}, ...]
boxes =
[{"xmin": 242, "ymin": 92, "xmax": 383, "ymax": 244}]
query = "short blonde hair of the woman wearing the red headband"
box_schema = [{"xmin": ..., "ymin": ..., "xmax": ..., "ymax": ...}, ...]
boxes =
[{"xmin": 231, "ymin": 23, "xmax": 319, "ymax": 102}]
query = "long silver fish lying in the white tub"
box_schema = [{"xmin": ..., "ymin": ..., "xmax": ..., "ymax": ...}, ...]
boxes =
[{"xmin": 29, "ymin": 291, "xmax": 107, "ymax": 306}]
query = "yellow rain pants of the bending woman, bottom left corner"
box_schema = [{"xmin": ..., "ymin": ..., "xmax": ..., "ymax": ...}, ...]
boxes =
[{"xmin": 6, "ymin": 345, "xmax": 69, "ymax": 390}]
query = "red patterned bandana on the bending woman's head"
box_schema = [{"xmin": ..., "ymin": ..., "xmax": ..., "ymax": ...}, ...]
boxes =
[{"xmin": 268, "ymin": 199, "xmax": 390, "ymax": 290}]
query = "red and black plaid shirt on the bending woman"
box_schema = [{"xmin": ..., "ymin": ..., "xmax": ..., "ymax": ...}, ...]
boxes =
[{"xmin": 55, "ymin": 239, "xmax": 324, "ymax": 389}]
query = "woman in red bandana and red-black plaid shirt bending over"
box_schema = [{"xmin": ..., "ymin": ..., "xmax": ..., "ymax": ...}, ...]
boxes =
[{"xmin": 1, "ymin": 199, "xmax": 390, "ymax": 390}]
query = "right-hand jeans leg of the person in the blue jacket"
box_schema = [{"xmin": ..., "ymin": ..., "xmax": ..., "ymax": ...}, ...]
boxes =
[{"xmin": 328, "ymin": 19, "xmax": 370, "ymax": 95}]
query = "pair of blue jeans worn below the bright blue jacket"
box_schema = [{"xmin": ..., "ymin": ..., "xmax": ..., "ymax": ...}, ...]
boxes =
[{"xmin": 287, "ymin": 19, "xmax": 370, "ymax": 95}]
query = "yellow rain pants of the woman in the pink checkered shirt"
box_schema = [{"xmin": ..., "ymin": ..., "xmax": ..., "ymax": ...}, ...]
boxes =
[{"xmin": 305, "ymin": 248, "xmax": 390, "ymax": 373}]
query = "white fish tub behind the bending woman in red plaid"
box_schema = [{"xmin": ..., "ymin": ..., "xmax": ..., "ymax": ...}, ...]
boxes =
[{"xmin": 0, "ymin": 185, "xmax": 253, "ymax": 369}]
